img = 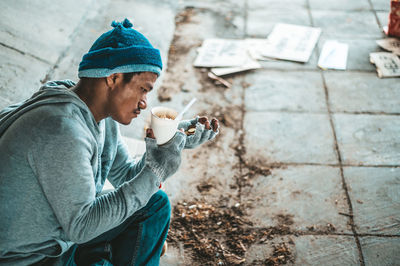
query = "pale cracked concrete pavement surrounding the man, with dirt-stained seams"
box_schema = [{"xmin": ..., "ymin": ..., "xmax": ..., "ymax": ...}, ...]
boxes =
[{"xmin": 0, "ymin": 0, "xmax": 400, "ymax": 265}]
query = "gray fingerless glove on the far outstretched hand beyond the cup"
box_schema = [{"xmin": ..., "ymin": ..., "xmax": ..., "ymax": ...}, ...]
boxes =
[{"xmin": 178, "ymin": 117, "xmax": 219, "ymax": 149}]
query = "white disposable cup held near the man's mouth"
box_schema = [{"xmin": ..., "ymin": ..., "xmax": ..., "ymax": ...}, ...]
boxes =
[{"xmin": 151, "ymin": 106, "xmax": 179, "ymax": 145}]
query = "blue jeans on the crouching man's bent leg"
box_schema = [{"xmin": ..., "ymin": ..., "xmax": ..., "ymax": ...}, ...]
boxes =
[{"xmin": 63, "ymin": 190, "xmax": 171, "ymax": 266}]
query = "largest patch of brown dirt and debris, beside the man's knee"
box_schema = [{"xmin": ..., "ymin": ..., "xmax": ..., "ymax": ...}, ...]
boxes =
[{"xmin": 168, "ymin": 197, "xmax": 255, "ymax": 265}]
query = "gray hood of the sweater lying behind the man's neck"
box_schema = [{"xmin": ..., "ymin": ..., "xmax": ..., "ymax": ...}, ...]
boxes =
[{"xmin": 0, "ymin": 80, "xmax": 96, "ymax": 137}]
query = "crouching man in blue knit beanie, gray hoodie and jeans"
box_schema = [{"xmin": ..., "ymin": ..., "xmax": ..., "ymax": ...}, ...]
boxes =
[{"xmin": 0, "ymin": 19, "xmax": 218, "ymax": 265}]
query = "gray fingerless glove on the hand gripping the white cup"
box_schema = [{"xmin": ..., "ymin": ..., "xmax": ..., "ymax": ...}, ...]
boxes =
[{"xmin": 145, "ymin": 131, "xmax": 186, "ymax": 182}]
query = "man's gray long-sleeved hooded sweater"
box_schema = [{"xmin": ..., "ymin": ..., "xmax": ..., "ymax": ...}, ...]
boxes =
[{"xmin": 0, "ymin": 81, "xmax": 166, "ymax": 265}]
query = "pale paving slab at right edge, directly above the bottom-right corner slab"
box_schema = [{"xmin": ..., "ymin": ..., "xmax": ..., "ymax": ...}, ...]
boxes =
[{"xmin": 343, "ymin": 167, "xmax": 400, "ymax": 236}]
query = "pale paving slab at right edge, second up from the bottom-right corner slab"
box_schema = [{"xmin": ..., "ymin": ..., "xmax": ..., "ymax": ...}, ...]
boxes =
[{"xmin": 333, "ymin": 114, "xmax": 400, "ymax": 165}]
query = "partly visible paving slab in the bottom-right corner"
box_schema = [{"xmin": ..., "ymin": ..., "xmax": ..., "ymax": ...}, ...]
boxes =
[{"xmin": 360, "ymin": 237, "xmax": 400, "ymax": 266}]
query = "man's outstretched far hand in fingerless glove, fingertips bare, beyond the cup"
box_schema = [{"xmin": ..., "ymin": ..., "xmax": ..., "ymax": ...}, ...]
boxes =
[{"xmin": 178, "ymin": 116, "xmax": 219, "ymax": 149}]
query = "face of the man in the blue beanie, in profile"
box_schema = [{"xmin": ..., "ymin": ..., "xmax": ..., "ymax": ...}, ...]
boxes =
[{"xmin": 107, "ymin": 72, "xmax": 157, "ymax": 125}]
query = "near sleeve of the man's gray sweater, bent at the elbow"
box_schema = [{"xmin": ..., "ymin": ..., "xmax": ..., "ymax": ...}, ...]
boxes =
[{"xmin": 28, "ymin": 116, "xmax": 159, "ymax": 243}]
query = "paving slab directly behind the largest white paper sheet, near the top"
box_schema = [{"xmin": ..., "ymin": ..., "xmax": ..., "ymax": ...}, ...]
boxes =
[{"xmin": 246, "ymin": 8, "xmax": 311, "ymax": 38}]
